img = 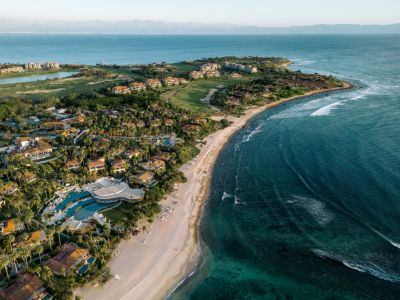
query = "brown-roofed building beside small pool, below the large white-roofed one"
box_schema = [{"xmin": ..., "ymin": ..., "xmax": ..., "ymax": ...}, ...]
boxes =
[{"xmin": 44, "ymin": 243, "xmax": 89, "ymax": 276}]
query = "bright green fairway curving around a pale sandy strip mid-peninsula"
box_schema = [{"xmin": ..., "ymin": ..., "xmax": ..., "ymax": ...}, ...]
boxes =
[{"xmin": 161, "ymin": 78, "xmax": 243, "ymax": 113}]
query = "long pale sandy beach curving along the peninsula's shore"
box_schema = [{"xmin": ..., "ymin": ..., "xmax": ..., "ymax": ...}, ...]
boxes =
[{"xmin": 75, "ymin": 84, "xmax": 351, "ymax": 300}]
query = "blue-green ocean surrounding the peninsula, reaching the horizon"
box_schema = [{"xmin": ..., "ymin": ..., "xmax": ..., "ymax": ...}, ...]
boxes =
[{"xmin": 0, "ymin": 35, "xmax": 400, "ymax": 299}]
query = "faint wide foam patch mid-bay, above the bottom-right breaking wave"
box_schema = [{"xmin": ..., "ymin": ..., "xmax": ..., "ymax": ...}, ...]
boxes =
[{"xmin": 287, "ymin": 196, "xmax": 334, "ymax": 226}]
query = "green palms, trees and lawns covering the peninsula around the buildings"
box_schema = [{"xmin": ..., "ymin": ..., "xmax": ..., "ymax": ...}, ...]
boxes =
[{"xmin": 0, "ymin": 57, "xmax": 342, "ymax": 299}]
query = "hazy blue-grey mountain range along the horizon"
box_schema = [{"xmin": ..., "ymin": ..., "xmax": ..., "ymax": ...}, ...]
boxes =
[{"xmin": 0, "ymin": 19, "xmax": 400, "ymax": 34}]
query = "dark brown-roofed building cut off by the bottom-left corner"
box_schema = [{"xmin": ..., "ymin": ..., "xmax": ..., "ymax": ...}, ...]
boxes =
[{"xmin": 0, "ymin": 273, "xmax": 51, "ymax": 300}]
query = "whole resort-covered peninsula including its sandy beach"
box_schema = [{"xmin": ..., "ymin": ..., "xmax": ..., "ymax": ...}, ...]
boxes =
[{"xmin": 0, "ymin": 57, "xmax": 351, "ymax": 299}]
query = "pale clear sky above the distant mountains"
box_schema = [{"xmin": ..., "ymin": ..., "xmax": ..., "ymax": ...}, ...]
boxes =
[{"xmin": 0, "ymin": 0, "xmax": 400, "ymax": 26}]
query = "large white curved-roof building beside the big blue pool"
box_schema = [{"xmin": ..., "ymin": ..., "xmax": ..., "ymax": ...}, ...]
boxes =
[{"xmin": 86, "ymin": 177, "xmax": 144, "ymax": 203}]
